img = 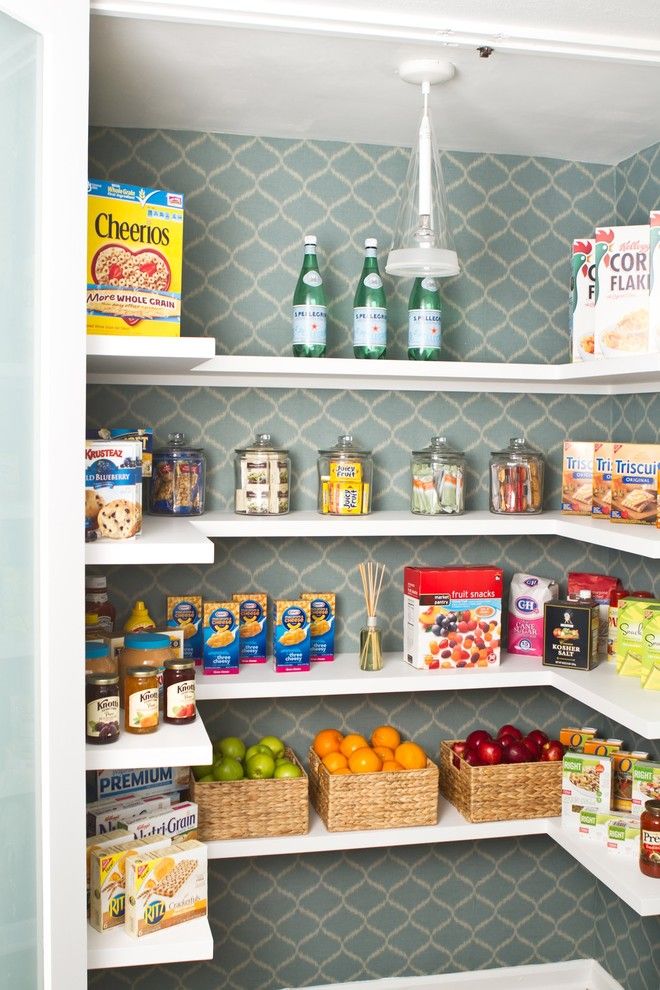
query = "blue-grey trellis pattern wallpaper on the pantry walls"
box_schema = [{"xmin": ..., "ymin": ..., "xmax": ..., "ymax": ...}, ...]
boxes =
[{"xmin": 88, "ymin": 129, "xmax": 660, "ymax": 990}]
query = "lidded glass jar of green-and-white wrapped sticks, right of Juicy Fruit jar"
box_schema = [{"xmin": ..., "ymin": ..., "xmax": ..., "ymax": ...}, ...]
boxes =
[{"xmin": 410, "ymin": 437, "xmax": 465, "ymax": 516}]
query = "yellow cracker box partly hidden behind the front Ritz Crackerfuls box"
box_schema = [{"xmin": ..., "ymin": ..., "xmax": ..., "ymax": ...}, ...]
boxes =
[{"xmin": 89, "ymin": 836, "xmax": 171, "ymax": 932}]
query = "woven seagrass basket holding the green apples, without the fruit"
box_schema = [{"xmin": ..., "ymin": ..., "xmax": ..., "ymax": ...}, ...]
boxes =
[{"xmin": 190, "ymin": 749, "xmax": 309, "ymax": 842}]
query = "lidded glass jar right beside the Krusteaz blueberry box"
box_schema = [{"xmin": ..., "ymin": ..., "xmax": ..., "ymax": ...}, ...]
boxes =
[{"xmin": 149, "ymin": 433, "xmax": 206, "ymax": 516}]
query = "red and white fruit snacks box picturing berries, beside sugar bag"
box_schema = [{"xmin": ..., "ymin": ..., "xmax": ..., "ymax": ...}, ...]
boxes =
[{"xmin": 403, "ymin": 567, "xmax": 503, "ymax": 670}]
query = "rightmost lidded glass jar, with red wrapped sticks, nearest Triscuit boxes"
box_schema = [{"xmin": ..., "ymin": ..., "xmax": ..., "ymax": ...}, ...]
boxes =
[{"xmin": 490, "ymin": 437, "xmax": 544, "ymax": 513}]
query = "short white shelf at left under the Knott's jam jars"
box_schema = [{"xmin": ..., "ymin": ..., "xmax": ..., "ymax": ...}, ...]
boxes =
[{"xmin": 85, "ymin": 710, "xmax": 213, "ymax": 770}]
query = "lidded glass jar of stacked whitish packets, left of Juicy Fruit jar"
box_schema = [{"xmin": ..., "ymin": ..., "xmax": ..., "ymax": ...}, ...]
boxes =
[{"xmin": 234, "ymin": 433, "xmax": 291, "ymax": 516}]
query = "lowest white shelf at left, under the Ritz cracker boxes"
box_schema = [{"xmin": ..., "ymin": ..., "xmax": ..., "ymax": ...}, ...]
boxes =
[{"xmin": 87, "ymin": 918, "xmax": 213, "ymax": 969}]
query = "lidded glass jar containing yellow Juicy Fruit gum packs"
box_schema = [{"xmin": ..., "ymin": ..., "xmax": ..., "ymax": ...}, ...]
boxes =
[{"xmin": 318, "ymin": 434, "xmax": 373, "ymax": 516}]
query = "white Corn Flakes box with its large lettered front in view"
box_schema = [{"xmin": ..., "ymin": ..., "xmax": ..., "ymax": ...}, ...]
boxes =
[{"xmin": 594, "ymin": 225, "xmax": 649, "ymax": 357}]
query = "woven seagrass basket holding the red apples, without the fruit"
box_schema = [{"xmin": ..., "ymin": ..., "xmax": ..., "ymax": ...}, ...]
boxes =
[{"xmin": 440, "ymin": 739, "xmax": 562, "ymax": 822}]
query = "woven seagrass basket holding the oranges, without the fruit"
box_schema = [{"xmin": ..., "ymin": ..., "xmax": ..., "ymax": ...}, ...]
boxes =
[{"xmin": 309, "ymin": 749, "xmax": 438, "ymax": 832}]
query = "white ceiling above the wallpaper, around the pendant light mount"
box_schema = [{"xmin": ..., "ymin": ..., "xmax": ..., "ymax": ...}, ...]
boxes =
[{"xmin": 90, "ymin": 0, "xmax": 660, "ymax": 163}]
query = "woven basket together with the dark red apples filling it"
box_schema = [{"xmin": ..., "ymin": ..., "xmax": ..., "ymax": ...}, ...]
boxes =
[{"xmin": 440, "ymin": 725, "xmax": 564, "ymax": 822}]
